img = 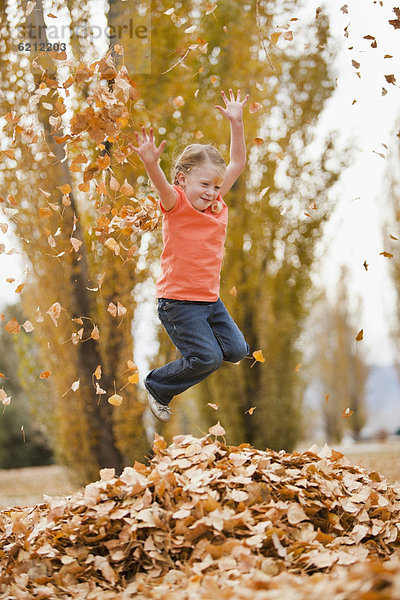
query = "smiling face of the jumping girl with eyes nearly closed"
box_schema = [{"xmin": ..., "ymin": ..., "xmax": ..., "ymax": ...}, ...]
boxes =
[{"xmin": 178, "ymin": 162, "xmax": 224, "ymax": 212}]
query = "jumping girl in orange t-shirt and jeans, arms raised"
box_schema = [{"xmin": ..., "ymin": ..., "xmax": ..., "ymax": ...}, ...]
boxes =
[{"xmin": 132, "ymin": 89, "xmax": 249, "ymax": 422}]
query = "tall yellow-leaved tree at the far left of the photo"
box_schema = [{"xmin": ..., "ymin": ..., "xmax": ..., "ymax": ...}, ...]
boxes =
[{"xmin": 1, "ymin": 1, "xmax": 149, "ymax": 480}]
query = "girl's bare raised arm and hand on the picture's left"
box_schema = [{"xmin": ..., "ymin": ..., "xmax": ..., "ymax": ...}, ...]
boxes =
[{"xmin": 130, "ymin": 125, "xmax": 177, "ymax": 212}]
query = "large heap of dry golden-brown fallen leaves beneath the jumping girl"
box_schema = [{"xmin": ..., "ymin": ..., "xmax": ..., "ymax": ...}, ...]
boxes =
[{"xmin": 0, "ymin": 424, "xmax": 400, "ymax": 600}]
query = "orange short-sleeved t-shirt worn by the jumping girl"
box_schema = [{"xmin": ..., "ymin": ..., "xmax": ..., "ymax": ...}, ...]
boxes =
[{"xmin": 157, "ymin": 185, "xmax": 228, "ymax": 302}]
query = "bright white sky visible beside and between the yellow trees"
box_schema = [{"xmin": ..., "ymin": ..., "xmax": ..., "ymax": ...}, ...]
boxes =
[{"xmin": 0, "ymin": 0, "xmax": 400, "ymax": 365}]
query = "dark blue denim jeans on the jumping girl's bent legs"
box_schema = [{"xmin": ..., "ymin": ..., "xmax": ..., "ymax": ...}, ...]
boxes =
[{"xmin": 144, "ymin": 298, "xmax": 249, "ymax": 405}]
